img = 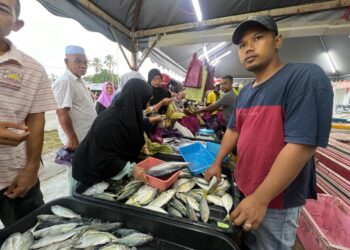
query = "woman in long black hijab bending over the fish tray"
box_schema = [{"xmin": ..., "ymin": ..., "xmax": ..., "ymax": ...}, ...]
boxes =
[{"xmin": 72, "ymin": 79, "xmax": 152, "ymax": 185}]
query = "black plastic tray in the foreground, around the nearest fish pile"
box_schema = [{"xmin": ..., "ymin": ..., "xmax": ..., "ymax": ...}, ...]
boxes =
[{"xmin": 0, "ymin": 197, "xmax": 239, "ymax": 250}]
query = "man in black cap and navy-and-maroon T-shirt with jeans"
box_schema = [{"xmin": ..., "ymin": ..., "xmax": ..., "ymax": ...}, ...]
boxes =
[{"xmin": 205, "ymin": 16, "xmax": 333, "ymax": 249}]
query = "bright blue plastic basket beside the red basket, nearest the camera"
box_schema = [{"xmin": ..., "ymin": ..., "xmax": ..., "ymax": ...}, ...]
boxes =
[{"xmin": 180, "ymin": 142, "xmax": 214, "ymax": 175}]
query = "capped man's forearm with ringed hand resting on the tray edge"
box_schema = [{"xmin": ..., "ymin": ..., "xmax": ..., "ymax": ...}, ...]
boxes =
[{"xmin": 230, "ymin": 143, "xmax": 316, "ymax": 230}]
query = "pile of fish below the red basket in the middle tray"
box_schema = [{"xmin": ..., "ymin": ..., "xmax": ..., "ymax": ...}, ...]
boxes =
[{"xmin": 83, "ymin": 168, "xmax": 233, "ymax": 223}]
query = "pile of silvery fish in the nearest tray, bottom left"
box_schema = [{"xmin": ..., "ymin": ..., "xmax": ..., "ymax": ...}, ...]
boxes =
[{"xmin": 1, "ymin": 205, "xmax": 153, "ymax": 250}]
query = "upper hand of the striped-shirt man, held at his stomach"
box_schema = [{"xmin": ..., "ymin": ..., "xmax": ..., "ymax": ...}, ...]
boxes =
[{"xmin": 0, "ymin": 121, "xmax": 30, "ymax": 147}]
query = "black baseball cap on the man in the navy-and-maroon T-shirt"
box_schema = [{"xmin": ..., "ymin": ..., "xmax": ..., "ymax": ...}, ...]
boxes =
[{"xmin": 232, "ymin": 15, "xmax": 278, "ymax": 45}]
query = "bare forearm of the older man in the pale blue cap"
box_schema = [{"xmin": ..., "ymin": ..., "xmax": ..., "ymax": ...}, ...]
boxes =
[{"xmin": 56, "ymin": 108, "xmax": 79, "ymax": 151}]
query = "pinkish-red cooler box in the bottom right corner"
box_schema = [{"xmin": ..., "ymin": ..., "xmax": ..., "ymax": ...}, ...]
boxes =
[{"xmin": 297, "ymin": 194, "xmax": 350, "ymax": 250}]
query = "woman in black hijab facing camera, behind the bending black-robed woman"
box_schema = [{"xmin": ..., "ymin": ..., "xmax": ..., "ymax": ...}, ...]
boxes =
[{"xmin": 148, "ymin": 69, "xmax": 171, "ymax": 114}]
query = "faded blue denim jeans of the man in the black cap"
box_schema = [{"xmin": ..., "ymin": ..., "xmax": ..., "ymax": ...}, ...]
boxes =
[{"xmin": 245, "ymin": 206, "xmax": 303, "ymax": 250}]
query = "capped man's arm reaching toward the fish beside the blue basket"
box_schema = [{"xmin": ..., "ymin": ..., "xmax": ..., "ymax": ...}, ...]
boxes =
[{"xmin": 204, "ymin": 128, "xmax": 239, "ymax": 181}]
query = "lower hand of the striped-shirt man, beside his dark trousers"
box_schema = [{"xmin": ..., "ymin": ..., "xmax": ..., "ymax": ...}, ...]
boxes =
[{"xmin": 4, "ymin": 169, "xmax": 38, "ymax": 199}]
